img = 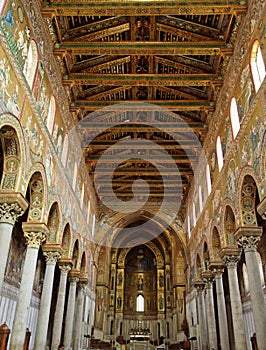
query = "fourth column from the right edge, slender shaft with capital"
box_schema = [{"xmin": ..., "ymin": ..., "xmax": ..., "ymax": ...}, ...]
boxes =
[{"xmin": 201, "ymin": 270, "xmax": 217, "ymax": 349}]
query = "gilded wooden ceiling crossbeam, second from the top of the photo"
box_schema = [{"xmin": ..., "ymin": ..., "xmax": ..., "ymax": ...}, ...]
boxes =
[{"xmin": 54, "ymin": 40, "xmax": 233, "ymax": 56}]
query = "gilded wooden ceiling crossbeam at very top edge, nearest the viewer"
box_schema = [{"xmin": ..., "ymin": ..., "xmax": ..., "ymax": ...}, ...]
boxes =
[{"xmin": 42, "ymin": 0, "xmax": 247, "ymax": 16}]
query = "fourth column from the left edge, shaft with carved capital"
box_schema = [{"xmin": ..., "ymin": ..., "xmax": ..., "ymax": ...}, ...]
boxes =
[{"xmin": 51, "ymin": 259, "xmax": 72, "ymax": 350}]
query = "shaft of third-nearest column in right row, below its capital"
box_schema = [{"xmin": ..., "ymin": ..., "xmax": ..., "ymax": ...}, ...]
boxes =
[{"xmin": 215, "ymin": 274, "xmax": 230, "ymax": 350}]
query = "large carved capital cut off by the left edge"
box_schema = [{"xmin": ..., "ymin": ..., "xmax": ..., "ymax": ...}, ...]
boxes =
[{"xmin": 0, "ymin": 192, "xmax": 29, "ymax": 225}]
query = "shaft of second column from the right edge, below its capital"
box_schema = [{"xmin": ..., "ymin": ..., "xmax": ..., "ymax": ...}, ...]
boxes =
[{"xmin": 227, "ymin": 264, "xmax": 247, "ymax": 350}]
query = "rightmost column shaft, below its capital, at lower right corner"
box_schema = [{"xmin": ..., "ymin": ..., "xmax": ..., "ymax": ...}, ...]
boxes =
[{"xmin": 244, "ymin": 248, "xmax": 266, "ymax": 349}]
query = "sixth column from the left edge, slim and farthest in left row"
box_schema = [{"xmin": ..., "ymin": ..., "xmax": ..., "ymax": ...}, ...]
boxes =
[{"xmin": 74, "ymin": 279, "xmax": 87, "ymax": 350}]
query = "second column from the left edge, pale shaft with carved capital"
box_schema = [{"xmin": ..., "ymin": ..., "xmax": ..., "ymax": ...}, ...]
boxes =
[{"xmin": 10, "ymin": 222, "xmax": 48, "ymax": 350}]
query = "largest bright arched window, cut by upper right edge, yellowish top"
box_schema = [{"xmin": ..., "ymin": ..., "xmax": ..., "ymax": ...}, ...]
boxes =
[{"xmin": 250, "ymin": 40, "xmax": 266, "ymax": 92}]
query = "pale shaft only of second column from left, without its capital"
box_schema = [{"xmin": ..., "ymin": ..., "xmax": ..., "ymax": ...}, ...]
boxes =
[{"xmin": 10, "ymin": 246, "xmax": 38, "ymax": 350}]
